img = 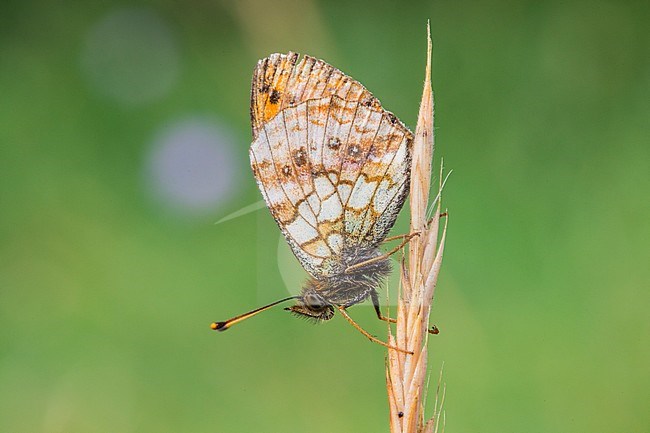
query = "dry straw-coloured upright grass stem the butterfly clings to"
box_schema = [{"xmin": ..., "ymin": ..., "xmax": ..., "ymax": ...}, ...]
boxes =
[{"xmin": 386, "ymin": 22, "xmax": 448, "ymax": 433}]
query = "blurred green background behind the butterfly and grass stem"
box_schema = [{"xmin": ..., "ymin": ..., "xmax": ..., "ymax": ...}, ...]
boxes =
[{"xmin": 0, "ymin": 0, "xmax": 650, "ymax": 433}]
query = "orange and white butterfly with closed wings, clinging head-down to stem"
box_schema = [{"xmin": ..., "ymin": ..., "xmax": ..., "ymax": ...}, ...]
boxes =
[{"xmin": 212, "ymin": 52, "xmax": 435, "ymax": 347}]
